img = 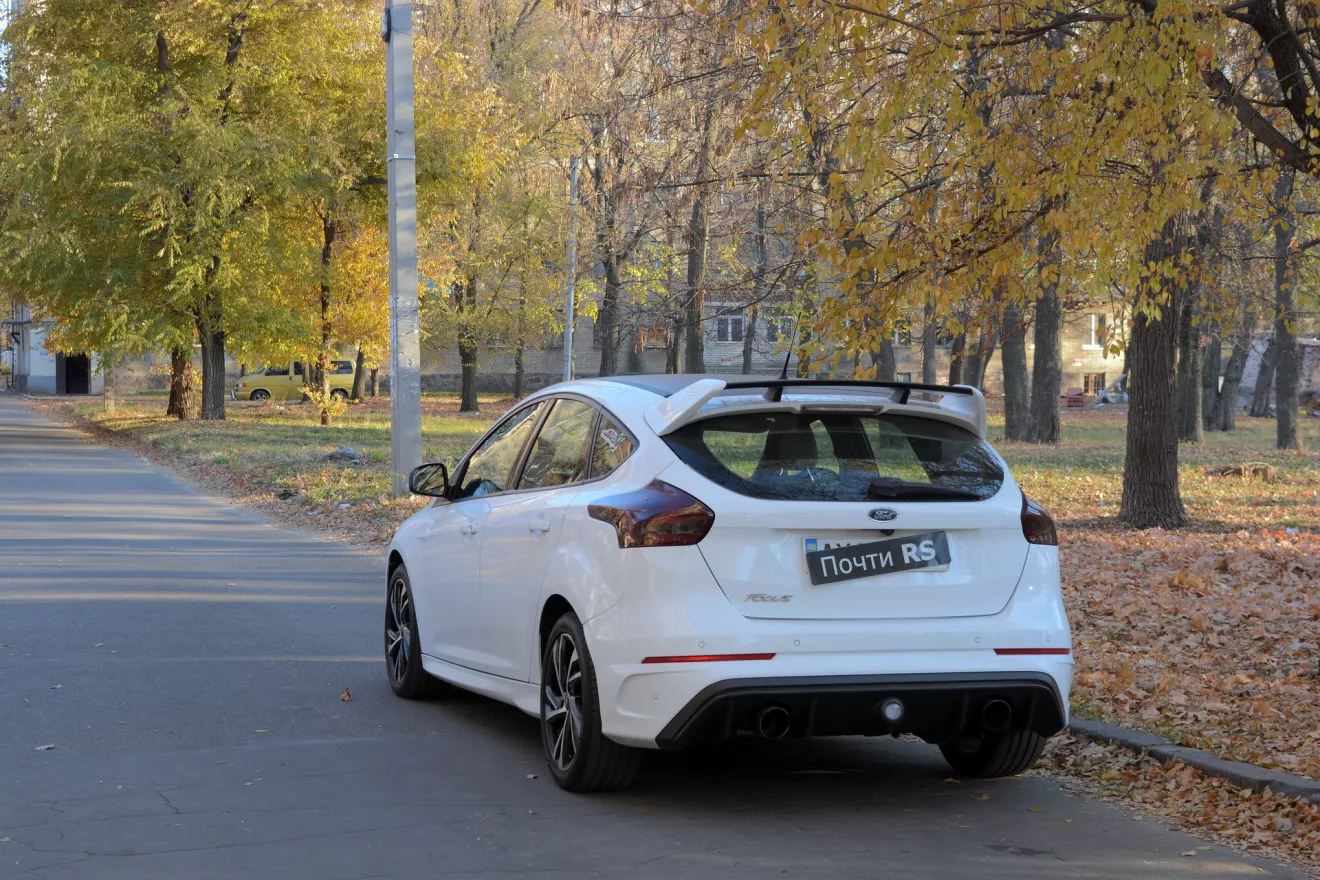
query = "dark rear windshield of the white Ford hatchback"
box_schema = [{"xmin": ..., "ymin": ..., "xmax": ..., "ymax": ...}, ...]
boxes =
[{"xmin": 665, "ymin": 413, "xmax": 1003, "ymax": 501}]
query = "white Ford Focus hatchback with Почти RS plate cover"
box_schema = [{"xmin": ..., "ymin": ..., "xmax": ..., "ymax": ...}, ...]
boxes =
[{"xmin": 385, "ymin": 376, "xmax": 1073, "ymax": 790}]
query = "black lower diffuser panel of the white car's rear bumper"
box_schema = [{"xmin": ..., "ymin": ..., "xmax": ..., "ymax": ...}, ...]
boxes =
[{"xmin": 655, "ymin": 673, "xmax": 1067, "ymax": 749}]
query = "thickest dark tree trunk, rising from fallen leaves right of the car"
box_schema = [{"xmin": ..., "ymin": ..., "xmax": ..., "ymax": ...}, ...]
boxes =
[{"xmin": 1119, "ymin": 219, "xmax": 1187, "ymax": 529}]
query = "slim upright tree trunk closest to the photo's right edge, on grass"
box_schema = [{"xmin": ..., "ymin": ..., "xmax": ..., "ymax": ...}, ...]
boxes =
[{"xmin": 1274, "ymin": 169, "xmax": 1302, "ymax": 450}]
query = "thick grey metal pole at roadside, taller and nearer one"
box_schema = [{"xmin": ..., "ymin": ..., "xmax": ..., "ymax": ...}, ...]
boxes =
[{"xmin": 380, "ymin": 0, "xmax": 421, "ymax": 497}]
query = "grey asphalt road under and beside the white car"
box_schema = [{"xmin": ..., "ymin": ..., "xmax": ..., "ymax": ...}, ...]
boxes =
[{"xmin": 0, "ymin": 396, "xmax": 1302, "ymax": 880}]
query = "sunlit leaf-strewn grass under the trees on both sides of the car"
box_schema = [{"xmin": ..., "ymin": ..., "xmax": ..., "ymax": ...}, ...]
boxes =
[{"xmin": 75, "ymin": 394, "xmax": 1320, "ymax": 529}]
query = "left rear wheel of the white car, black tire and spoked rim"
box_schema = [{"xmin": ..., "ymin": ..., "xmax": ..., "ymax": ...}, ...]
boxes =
[{"xmin": 541, "ymin": 612, "xmax": 640, "ymax": 792}]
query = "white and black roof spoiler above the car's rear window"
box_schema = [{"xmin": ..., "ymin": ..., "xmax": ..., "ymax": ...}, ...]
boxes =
[{"xmin": 645, "ymin": 376, "xmax": 986, "ymax": 439}]
